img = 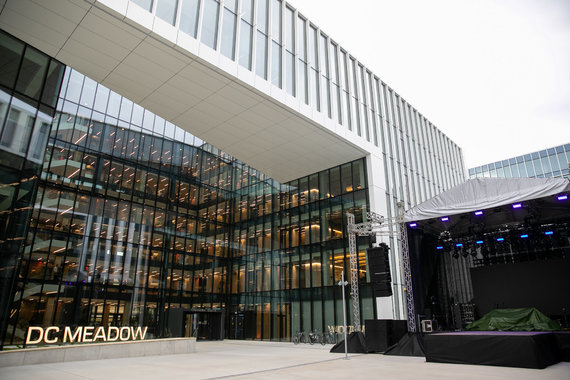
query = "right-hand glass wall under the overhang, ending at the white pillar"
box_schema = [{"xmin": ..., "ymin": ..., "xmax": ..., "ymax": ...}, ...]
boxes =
[{"xmin": 229, "ymin": 156, "xmax": 374, "ymax": 340}]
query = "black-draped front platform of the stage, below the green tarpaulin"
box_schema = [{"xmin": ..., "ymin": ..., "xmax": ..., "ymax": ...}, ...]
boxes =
[{"xmin": 424, "ymin": 331, "xmax": 568, "ymax": 369}]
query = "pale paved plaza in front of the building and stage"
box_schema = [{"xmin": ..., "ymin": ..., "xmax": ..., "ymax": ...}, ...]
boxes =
[{"xmin": 0, "ymin": 340, "xmax": 570, "ymax": 380}]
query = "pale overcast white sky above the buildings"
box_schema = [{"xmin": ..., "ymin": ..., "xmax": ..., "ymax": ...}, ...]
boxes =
[{"xmin": 288, "ymin": 0, "xmax": 570, "ymax": 168}]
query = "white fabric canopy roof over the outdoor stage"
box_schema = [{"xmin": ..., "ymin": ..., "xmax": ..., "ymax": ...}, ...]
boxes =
[{"xmin": 404, "ymin": 178, "xmax": 570, "ymax": 222}]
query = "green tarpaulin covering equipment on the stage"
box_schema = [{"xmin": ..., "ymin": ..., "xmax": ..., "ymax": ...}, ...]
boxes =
[{"xmin": 466, "ymin": 308, "xmax": 561, "ymax": 331}]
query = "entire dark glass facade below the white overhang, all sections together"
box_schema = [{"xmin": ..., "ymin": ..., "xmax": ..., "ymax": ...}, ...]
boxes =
[{"xmin": 0, "ymin": 34, "xmax": 374, "ymax": 345}]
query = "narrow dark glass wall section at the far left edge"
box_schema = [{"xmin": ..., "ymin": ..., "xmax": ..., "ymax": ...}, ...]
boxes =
[{"xmin": 0, "ymin": 31, "xmax": 65, "ymax": 347}]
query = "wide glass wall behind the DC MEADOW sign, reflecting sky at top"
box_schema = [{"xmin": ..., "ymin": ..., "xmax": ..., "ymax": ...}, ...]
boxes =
[{"xmin": 9, "ymin": 69, "xmax": 238, "ymax": 344}]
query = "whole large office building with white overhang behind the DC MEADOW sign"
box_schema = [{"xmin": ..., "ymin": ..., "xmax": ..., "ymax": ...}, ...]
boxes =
[{"xmin": 0, "ymin": 0, "xmax": 465, "ymax": 346}]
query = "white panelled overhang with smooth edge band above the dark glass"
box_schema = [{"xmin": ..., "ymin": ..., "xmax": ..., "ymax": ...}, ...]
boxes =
[{"xmin": 0, "ymin": 0, "xmax": 367, "ymax": 182}]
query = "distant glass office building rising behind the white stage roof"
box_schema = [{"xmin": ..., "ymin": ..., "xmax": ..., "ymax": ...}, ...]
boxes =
[{"xmin": 469, "ymin": 144, "xmax": 570, "ymax": 182}]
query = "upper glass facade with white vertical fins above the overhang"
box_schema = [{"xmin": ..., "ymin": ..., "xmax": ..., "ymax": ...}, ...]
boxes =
[{"xmin": 120, "ymin": 0, "xmax": 466, "ymax": 318}]
